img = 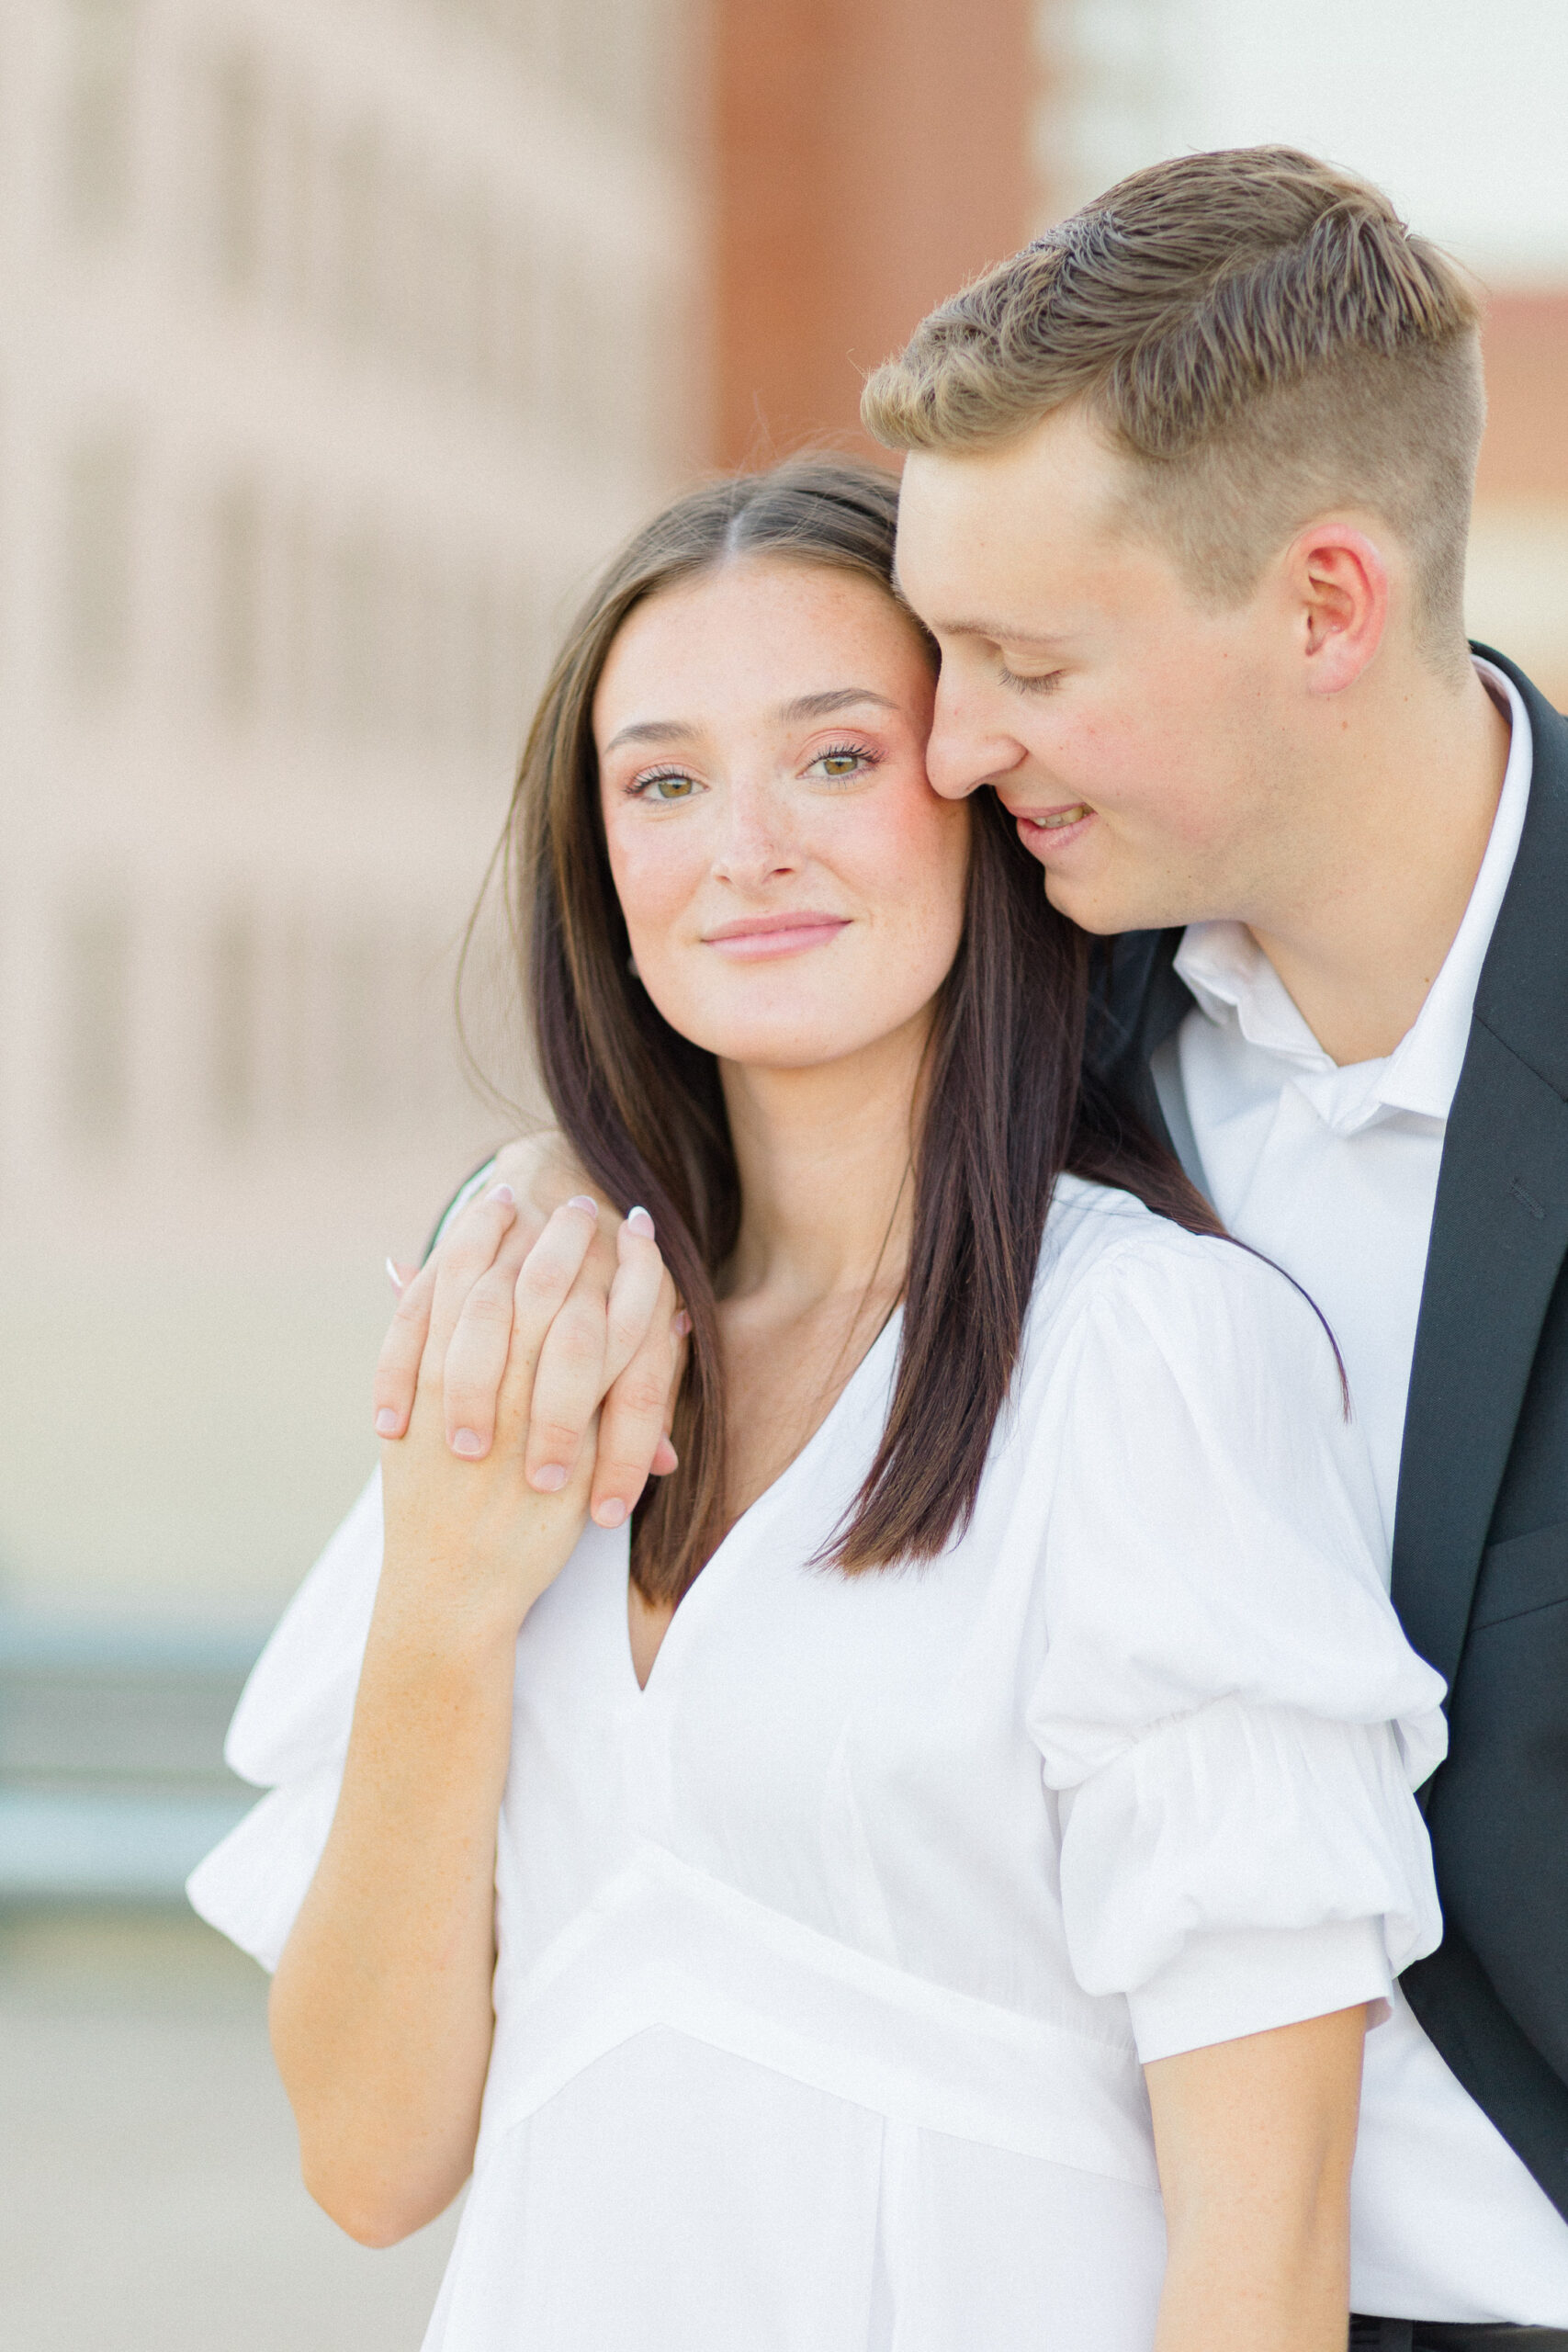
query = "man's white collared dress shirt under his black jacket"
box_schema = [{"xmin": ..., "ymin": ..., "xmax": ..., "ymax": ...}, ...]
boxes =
[{"xmin": 1155, "ymin": 661, "xmax": 1568, "ymax": 2326}]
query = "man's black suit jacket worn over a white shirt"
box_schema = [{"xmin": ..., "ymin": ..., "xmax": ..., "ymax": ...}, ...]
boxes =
[{"xmin": 1093, "ymin": 647, "xmax": 1568, "ymax": 2216}]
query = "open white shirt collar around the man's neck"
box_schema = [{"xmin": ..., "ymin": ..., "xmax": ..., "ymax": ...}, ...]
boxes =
[{"xmin": 1176, "ymin": 661, "xmax": 1533, "ymax": 1131}]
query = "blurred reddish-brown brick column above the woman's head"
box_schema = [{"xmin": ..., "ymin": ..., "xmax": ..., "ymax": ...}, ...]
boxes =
[{"xmin": 715, "ymin": 0, "xmax": 1039, "ymax": 463}]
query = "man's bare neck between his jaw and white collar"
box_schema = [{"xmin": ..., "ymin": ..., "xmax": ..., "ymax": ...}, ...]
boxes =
[{"xmin": 1248, "ymin": 671, "xmax": 1509, "ymax": 1066}]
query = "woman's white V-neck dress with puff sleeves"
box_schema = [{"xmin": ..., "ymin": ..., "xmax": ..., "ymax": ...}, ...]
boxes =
[{"xmin": 190, "ymin": 1181, "xmax": 1443, "ymax": 2352}]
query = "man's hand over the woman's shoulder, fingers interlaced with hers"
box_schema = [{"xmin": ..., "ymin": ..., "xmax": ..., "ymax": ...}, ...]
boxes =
[{"xmin": 374, "ymin": 1134, "xmax": 689, "ymax": 1526}]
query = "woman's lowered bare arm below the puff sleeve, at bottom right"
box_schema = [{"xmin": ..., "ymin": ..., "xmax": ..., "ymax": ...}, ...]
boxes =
[{"xmin": 1145, "ymin": 2007, "xmax": 1366, "ymax": 2352}]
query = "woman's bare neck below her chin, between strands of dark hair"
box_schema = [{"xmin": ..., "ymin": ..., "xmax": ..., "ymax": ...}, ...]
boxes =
[{"xmin": 722, "ymin": 1013, "xmax": 931, "ymax": 1312}]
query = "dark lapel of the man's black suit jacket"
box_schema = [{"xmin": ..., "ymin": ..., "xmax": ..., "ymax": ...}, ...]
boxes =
[{"xmin": 1394, "ymin": 647, "xmax": 1568, "ymax": 1681}]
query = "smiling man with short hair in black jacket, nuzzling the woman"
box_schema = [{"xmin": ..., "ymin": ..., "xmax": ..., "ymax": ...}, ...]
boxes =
[{"xmin": 378, "ymin": 148, "xmax": 1568, "ymax": 2352}]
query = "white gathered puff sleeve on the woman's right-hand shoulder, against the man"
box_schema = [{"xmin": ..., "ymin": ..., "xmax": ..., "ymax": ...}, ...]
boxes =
[{"xmin": 1030, "ymin": 1227, "xmax": 1446, "ymax": 2061}]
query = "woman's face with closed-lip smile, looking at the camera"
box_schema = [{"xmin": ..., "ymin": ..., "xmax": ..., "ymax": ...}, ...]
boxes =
[{"xmin": 592, "ymin": 558, "xmax": 968, "ymax": 1070}]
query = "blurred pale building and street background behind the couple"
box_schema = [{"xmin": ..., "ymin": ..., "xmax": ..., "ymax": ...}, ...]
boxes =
[{"xmin": 0, "ymin": 0, "xmax": 1568, "ymax": 2352}]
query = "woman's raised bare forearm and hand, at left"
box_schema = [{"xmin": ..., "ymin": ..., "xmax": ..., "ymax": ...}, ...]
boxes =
[{"xmin": 270, "ymin": 1202, "xmax": 663, "ymax": 2246}]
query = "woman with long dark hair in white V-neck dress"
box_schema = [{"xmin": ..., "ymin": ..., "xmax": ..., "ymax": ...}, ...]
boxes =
[{"xmin": 193, "ymin": 463, "xmax": 1443, "ymax": 2352}]
